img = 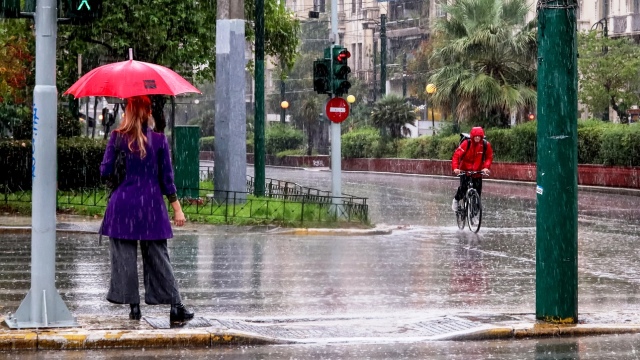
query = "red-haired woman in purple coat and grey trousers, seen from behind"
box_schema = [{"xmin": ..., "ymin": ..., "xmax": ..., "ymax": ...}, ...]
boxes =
[{"xmin": 100, "ymin": 96, "xmax": 194, "ymax": 322}]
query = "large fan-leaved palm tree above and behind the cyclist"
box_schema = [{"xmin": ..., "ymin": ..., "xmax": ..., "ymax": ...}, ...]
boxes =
[{"xmin": 430, "ymin": 0, "xmax": 537, "ymax": 126}]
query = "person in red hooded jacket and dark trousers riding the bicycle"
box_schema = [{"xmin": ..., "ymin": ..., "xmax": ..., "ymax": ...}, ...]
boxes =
[{"xmin": 451, "ymin": 126, "xmax": 493, "ymax": 211}]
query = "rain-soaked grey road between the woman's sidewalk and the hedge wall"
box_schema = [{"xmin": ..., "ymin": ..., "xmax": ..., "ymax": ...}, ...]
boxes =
[{"xmin": 0, "ymin": 168, "xmax": 640, "ymax": 359}]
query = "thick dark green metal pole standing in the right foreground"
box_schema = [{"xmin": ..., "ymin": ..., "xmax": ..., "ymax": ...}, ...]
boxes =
[{"xmin": 536, "ymin": 0, "xmax": 578, "ymax": 323}]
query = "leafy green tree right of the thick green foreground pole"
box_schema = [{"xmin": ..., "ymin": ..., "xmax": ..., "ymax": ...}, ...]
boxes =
[{"xmin": 578, "ymin": 30, "xmax": 640, "ymax": 123}]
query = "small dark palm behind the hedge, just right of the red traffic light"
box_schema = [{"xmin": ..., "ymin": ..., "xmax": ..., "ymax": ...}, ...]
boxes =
[{"xmin": 371, "ymin": 94, "xmax": 416, "ymax": 139}]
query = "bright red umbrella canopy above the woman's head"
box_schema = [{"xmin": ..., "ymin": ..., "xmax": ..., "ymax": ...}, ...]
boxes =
[{"xmin": 64, "ymin": 60, "xmax": 201, "ymax": 99}]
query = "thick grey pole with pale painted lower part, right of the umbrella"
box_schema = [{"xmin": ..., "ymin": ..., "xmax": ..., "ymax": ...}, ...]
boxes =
[{"xmin": 214, "ymin": 0, "xmax": 247, "ymax": 201}]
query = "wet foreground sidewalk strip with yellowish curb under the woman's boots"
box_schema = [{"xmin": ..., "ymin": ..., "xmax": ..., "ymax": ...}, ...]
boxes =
[{"xmin": 0, "ymin": 313, "xmax": 640, "ymax": 351}]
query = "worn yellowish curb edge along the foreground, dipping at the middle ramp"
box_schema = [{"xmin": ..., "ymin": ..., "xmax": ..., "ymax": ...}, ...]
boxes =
[{"xmin": 0, "ymin": 324, "xmax": 640, "ymax": 351}]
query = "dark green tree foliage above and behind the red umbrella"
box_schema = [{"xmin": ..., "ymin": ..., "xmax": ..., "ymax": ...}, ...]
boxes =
[{"xmin": 58, "ymin": 0, "xmax": 300, "ymax": 88}]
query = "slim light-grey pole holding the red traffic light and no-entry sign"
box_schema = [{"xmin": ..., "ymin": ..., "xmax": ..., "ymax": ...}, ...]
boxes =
[{"xmin": 330, "ymin": 1, "xmax": 342, "ymax": 205}]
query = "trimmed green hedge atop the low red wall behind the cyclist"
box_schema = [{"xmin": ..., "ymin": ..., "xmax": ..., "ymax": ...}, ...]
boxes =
[{"xmin": 342, "ymin": 120, "xmax": 640, "ymax": 166}]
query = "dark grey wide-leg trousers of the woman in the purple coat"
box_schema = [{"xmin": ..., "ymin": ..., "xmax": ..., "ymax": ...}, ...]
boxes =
[{"xmin": 107, "ymin": 238, "xmax": 181, "ymax": 305}]
